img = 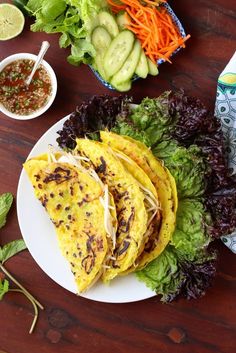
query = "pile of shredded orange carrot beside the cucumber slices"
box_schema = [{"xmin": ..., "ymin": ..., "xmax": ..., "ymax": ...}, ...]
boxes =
[{"xmin": 107, "ymin": 0, "xmax": 190, "ymax": 63}]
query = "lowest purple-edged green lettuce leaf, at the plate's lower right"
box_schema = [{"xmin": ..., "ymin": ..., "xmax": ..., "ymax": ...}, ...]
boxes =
[{"xmin": 135, "ymin": 245, "xmax": 216, "ymax": 302}]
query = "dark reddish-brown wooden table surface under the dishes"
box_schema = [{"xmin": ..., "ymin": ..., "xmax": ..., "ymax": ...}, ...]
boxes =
[{"xmin": 0, "ymin": 0, "xmax": 236, "ymax": 353}]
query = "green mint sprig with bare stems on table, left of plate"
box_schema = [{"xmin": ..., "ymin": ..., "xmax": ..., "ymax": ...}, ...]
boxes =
[{"xmin": 0, "ymin": 193, "xmax": 43, "ymax": 334}]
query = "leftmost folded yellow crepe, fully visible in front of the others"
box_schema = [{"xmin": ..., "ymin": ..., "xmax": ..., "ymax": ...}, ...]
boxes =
[{"xmin": 24, "ymin": 154, "xmax": 109, "ymax": 292}]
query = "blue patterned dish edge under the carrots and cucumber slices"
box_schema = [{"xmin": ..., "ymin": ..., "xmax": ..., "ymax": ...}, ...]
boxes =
[{"xmin": 90, "ymin": 3, "xmax": 186, "ymax": 90}]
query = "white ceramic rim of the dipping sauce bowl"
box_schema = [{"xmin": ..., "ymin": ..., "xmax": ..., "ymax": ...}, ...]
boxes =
[{"xmin": 0, "ymin": 53, "xmax": 57, "ymax": 120}]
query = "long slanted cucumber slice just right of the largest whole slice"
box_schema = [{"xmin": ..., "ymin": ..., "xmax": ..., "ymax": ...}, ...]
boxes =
[{"xmin": 113, "ymin": 40, "xmax": 142, "ymax": 84}]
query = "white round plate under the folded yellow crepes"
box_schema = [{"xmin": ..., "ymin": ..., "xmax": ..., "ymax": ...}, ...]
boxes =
[{"xmin": 17, "ymin": 116, "xmax": 156, "ymax": 303}]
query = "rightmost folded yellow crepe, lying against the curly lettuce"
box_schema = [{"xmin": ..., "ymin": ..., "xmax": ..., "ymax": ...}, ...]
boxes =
[{"xmin": 100, "ymin": 131, "xmax": 178, "ymax": 269}]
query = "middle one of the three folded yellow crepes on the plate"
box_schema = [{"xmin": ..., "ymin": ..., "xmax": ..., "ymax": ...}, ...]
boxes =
[{"xmin": 75, "ymin": 139, "xmax": 148, "ymax": 282}]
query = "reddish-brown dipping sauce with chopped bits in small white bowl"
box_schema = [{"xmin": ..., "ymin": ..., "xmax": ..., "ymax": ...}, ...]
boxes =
[{"xmin": 0, "ymin": 59, "xmax": 52, "ymax": 115}]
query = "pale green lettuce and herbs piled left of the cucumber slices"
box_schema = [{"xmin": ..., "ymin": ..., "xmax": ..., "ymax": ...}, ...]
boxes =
[{"xmin": 24, "ymin": 0, "xmax": 107, "ymax": 65}]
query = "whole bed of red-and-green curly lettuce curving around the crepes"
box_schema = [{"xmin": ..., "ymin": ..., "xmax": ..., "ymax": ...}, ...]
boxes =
[{"xmin": 57, "ymin": 91, "xmax": 236, "ymax": 302}]
